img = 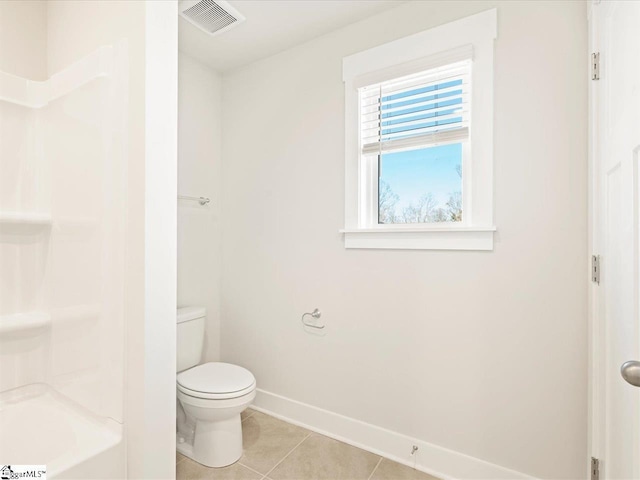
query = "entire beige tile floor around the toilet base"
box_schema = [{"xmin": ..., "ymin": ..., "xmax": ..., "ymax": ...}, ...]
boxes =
[{"xmin": 176, "ymin": 409, "xmax": 437, "ymax": 480}]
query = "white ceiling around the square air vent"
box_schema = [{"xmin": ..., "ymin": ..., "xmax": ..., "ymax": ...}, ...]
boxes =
[{"xmin": 179, "ymin": 0, "xmax": 404, "ymax": 71}]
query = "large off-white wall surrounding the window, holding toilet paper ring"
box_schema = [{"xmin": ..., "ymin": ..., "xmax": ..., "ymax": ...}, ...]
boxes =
[{"xmin": 221, "ymin": 1, "xmax": 588, "ymax": 479}]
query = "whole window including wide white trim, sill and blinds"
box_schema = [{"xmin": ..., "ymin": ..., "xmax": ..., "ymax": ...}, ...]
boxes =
[{"xmin": 342, "ymin": 10, "xmax": 497, "ymax": 250}]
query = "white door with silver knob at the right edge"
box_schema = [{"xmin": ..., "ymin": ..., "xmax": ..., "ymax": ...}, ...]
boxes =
[{"xmin": 590, "ymin": 0, "xmax": 640, "ymax": 480}]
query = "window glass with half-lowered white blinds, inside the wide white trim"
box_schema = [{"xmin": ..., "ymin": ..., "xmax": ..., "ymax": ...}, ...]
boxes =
[{"xmin": 358, "ymin": 60, "xmax": 471, "ymax": 225}]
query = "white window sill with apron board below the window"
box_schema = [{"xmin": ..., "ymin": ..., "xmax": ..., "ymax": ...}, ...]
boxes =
[{"xmin": 340, "ymin": 226, "xmax": 496, "ymax": 251}]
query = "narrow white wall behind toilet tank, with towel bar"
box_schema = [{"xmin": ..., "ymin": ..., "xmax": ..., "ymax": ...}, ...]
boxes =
[{"xmin": 178, "ymin": 53, "xmax": 222, "ymax": 361}]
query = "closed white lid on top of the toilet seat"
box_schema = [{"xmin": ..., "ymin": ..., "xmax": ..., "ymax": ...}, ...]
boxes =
[{"xmin": 178, "ymin": 362, "xmax": 256, "ymax": 393}]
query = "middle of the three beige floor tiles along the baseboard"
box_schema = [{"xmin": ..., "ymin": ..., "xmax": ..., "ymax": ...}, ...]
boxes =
[{"xmin": 269, "ymin": 434, "xmax": 380, "ymax": 480}]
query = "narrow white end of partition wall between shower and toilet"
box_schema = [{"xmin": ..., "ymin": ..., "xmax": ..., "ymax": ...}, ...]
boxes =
[{"xmin": 142, "ymin": 1, "xmax": 178, "ymax": 479}]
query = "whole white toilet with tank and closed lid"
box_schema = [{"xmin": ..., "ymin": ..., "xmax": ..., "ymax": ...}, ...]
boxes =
[{"xmin": 177, "ymin": 307, "xmax": 256, "ymax": 467}]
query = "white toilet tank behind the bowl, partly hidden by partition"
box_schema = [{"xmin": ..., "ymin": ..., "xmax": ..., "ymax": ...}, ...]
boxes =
[{"xmin": 176, "ymin": 307, "xmax": 207, "ymax": 372}]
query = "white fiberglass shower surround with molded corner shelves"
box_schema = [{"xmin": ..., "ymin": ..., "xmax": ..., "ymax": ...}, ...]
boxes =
[{"xmin": 0, "ymin": 42, "xmax": 128, "ymax": 473}]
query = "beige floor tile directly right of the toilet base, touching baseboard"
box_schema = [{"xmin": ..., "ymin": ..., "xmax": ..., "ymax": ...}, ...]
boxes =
[{"xmin": 240, "ymin": 412, "xmax": 310, "ymax": 474}]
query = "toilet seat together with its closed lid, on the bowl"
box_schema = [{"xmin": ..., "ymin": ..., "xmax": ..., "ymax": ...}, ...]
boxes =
[{"xmin": 177, "ymin": 362, "xmax": 256, "ymax": 400}]
